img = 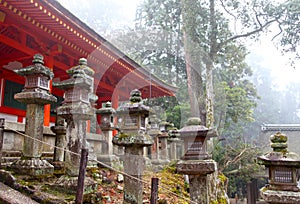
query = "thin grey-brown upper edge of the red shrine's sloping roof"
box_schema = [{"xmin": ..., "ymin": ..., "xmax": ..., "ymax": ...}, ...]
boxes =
[{"xmin": 44, "ymin": 0, "xmax": 179, "ymax": 96}]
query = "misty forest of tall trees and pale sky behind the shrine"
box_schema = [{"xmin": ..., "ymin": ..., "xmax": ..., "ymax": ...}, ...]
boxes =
[{"xmin": 59, "ymin": 0, "xmax": 300, "ymax": 196}]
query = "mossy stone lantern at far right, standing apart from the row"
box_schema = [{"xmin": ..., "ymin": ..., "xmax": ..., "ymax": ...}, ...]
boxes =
[{"xmin": 258, "ymin": 132, "xmax": 300, "ymax": 203}]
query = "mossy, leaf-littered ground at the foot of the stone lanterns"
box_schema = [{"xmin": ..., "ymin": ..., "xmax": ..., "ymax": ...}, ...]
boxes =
[{"xmin": 3, "ymin": 165, "xmax": 189, "ymax": 204}]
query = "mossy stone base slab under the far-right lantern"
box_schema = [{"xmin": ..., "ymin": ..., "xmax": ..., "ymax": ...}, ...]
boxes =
[{"xmin": 260, "ymin": 187, "xmax": 300, "ymax": 204}]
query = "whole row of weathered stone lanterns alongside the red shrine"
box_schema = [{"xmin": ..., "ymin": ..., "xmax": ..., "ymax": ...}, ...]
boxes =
[{"xmin": 12, "ymin": 54, "xmax": 220, "ymax": 203}]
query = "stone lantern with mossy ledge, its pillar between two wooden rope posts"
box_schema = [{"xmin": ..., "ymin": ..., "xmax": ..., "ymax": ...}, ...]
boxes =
[{"xmin": 113, "ymin": 89, "xmax": 153, "ymax": 203}]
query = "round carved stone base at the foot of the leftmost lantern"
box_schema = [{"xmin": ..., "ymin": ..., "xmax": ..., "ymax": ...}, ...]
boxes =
[{"xmin": 11, "ymin": 158, "xmax": 54, "ymax": 177}]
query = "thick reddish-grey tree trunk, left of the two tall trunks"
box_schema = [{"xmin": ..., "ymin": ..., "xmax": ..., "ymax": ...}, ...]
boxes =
[{"xmin": 182, "ymin": 0, "xmax": 206, "ymax": 125}]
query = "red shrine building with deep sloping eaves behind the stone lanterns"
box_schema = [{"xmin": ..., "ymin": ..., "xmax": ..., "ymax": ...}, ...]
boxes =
[{"xmin": 0, "ymin": 0, "xmax": 176, "ymax": 126}]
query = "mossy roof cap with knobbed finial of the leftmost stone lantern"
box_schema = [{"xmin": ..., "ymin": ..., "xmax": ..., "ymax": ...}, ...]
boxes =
[{"xmin": 15, "ymin": 54, "xmax": 54, "ymax": 79}]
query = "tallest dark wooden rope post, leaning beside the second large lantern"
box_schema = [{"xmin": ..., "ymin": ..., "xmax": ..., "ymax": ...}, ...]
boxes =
[{"xmin": 75, "ymin": 148, "xmax": 89, "ymax": 204}]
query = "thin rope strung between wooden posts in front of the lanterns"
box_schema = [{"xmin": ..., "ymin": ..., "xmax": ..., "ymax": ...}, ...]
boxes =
[{"xmin": 4, "ymin": 125, "xmax": 197, "ymax": 204}]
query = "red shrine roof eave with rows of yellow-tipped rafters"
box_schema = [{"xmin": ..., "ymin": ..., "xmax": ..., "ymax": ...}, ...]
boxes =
[{"xmin": 0, "ymin": 0, "xmax": 178, "ymax": 100}]
